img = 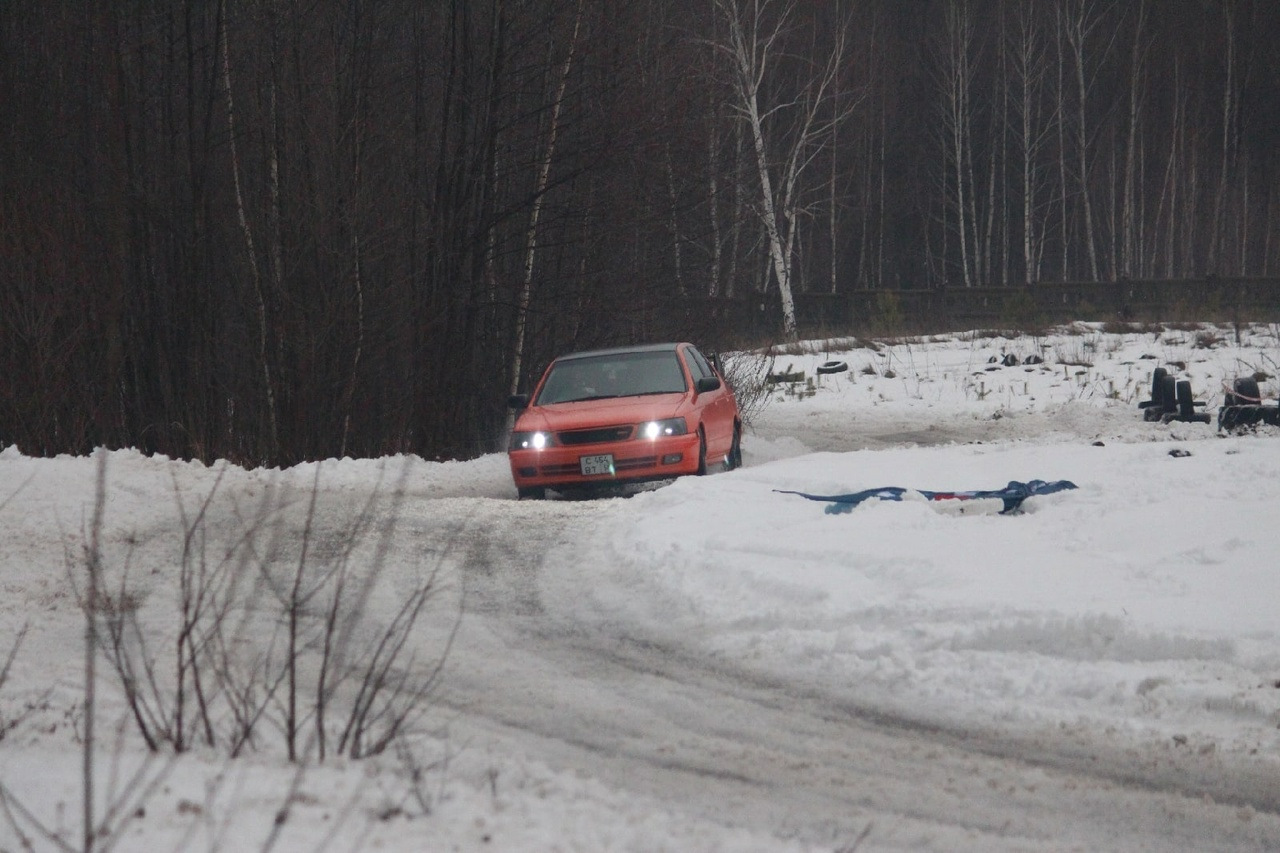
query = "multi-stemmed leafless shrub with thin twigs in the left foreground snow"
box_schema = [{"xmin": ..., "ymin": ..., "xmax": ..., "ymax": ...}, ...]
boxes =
[{"xmin": 82, "ymin": 455, "xmax": 457, "ymax": 762}]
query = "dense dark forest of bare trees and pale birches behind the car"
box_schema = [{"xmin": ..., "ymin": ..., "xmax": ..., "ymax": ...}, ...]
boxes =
[{"xmin": 0, "ymin": 0, "xmax": 1280, "ymax": 465}]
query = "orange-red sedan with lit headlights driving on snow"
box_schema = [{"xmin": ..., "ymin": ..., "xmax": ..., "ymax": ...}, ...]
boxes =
[{"xmin": 507, "ymin": 343, "xmax": 742, "ymax": 498}]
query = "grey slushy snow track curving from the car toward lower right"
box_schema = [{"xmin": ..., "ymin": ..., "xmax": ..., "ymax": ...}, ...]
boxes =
[{"xmin": 417, "ymin": 481, "xmax": 1280, "ymax": 850}]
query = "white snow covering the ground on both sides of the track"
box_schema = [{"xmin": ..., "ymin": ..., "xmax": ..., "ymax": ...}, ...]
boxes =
[{"xmin": 0, "ymin": 318, "xmax": 1280, "ymax": 850}]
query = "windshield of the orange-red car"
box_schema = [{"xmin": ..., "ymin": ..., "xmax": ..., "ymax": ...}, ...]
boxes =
[{"xmin": 534, "ymin": 350, "xmax": 686, "ymax": 406}]
